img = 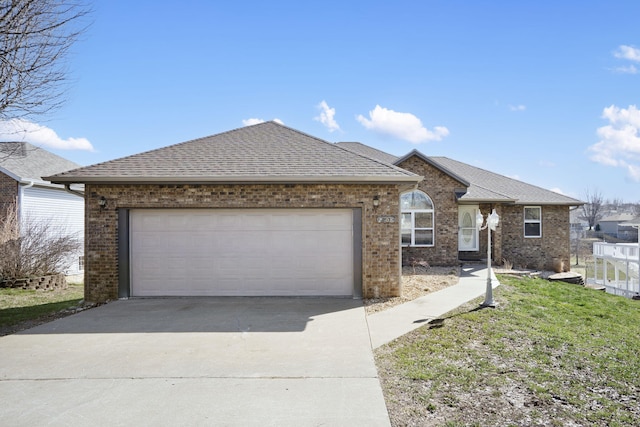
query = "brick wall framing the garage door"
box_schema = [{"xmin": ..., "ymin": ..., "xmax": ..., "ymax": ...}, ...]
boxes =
[{"xmin": 85, "ymin": 184, "xmax": 401, "ymax": 302}]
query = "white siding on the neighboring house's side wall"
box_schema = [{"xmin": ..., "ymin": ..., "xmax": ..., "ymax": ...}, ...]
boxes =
[{"xmin": 20, "ymin": 186, "xmax": 84, "ymax": 274}]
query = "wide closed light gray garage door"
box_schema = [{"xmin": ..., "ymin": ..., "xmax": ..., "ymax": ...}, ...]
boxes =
[{"xmin": 130, "ymin": 209, "xmax": 354, "ymax": 296}]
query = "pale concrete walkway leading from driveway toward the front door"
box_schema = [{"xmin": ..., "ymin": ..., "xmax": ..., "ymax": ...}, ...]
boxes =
[{"xmin": 367, "ymin": 265, "xmax": 500, "ymax": 349}]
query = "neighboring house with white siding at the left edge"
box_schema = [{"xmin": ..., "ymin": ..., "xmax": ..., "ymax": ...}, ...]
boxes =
[{"xmin": 0, "ymin": 142, "xmax": 84, "ymax": 275}]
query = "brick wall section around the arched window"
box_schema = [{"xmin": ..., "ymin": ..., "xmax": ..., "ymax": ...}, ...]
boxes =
[{"xmin": 398, "ymin": 156, "xmax": 462, "ymax": 266}]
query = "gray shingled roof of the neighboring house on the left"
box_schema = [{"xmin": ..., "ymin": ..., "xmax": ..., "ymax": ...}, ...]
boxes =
[{"xmin": 0, "ymin": 142, "xmax": 80, "ymax": 182}]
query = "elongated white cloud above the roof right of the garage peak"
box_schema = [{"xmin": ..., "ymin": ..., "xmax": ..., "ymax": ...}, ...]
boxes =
[{"xmin": 357, "ymin": 105, "xmax": 449, "ymax": 144}]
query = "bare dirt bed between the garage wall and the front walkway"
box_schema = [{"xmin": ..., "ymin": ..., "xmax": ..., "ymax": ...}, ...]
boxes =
[{"xmin": 363, "ymin": 266, "xmax": 460, "ymax": 314}]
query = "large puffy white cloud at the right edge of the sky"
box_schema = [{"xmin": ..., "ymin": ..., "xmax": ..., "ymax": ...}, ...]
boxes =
[{"xmin": 589, "ymin": 105, "xmax": 640, "ymax": 181}]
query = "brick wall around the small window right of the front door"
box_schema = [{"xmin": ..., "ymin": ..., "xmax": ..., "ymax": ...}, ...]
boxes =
[{"xmin": 498, "ymin": 205, "xmax": 570, "ymax": 270}]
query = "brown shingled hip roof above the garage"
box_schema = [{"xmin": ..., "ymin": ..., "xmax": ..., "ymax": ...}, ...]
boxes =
[{"xmin": 49, "ymin": 122, "xmax": 422, "ymax": 183}]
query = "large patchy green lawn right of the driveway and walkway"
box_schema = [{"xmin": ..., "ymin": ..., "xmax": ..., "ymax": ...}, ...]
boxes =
[{"xmin": 378, "ymin": 277, "xmax": 640, "ymax": 426}]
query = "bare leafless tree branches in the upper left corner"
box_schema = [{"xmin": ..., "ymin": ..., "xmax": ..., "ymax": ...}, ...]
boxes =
[{"xmin": 0, "ymin": 0, "xmax": 89, "ymax": 120}]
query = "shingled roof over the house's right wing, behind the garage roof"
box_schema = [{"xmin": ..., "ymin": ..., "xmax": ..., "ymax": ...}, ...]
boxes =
[{"xmin": 337, "ymin": 142, "xmax": 584, "ymax": 206}]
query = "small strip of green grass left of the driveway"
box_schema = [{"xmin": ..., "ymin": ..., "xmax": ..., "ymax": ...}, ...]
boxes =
[{"xmin": 0, "ymin": 284, "xmax": 84, "ymax": 328}]
